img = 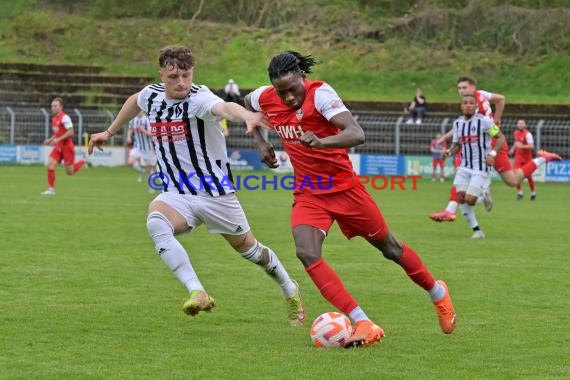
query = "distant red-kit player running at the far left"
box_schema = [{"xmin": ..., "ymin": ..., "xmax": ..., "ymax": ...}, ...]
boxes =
[{"xmin": 41, "ymin": 98, "xmax": 85, "ymax": 195}]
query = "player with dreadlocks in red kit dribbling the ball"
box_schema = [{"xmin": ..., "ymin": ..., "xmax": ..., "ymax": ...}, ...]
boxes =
[{"xmin": 245, "ymin": 51, "xmax": 456, "ymax": 347}]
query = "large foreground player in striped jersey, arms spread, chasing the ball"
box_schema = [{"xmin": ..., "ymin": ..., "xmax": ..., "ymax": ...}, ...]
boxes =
[{"xmin": 89, "ymin": 45, "xmax": 305, "ymax": 325}]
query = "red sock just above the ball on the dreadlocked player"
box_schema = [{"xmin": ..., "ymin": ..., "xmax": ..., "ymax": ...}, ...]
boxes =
[{"xmin": 305, "ymin": 259, "xmax": 358, "ymax": 315}]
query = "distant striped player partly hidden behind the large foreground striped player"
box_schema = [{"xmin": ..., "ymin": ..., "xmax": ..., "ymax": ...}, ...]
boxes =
[{"xmin": 127, "ymin": 111, "xmax": 156, "ymax": 186}]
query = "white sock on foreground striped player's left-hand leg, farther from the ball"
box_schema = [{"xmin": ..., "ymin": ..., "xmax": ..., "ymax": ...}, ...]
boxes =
[{"xmin": 146, "ymin": 211, "xmax": 204, "ymax": 292}]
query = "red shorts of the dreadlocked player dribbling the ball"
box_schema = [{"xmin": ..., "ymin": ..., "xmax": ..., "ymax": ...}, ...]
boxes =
[{"xmin": 291, "ymin": 184, "xmax": 389, "ymax": 240}]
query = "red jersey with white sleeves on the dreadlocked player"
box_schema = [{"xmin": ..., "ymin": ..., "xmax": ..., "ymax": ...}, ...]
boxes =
[{"xmin": 251, "ymin": 80, "xmax": 355, "ymax": 194}]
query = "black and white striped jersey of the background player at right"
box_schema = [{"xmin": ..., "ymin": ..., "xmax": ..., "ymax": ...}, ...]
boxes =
[{"xmin": 453, "ymin": 114, "xmax": 494, "ymax": 173}]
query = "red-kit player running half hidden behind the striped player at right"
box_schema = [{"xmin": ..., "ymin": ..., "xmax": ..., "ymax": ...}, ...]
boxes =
[{"xmin": 430, "ymin": 76, "xmax": 561, "ymax": 222}]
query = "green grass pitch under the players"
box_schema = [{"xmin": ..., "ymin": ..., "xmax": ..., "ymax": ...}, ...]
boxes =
[{"xmin": 0, "ymin": 166, "xmax": 570, "ymax": 379}]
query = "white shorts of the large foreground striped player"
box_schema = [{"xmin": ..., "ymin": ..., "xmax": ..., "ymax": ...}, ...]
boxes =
[{"xmin": 154, "ymin": 191, "xmax": 250, "ymax": 235}]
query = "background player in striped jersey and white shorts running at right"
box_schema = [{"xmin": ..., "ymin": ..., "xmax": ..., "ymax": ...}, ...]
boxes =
[{"xmin": 445, "ymin": 94, "xmax": 505, "ymax": 239}]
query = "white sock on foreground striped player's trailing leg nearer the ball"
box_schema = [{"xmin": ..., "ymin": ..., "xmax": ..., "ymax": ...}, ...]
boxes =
[{"xmin": 240, "ymin": 241, "xmax": 297, "ymax": 298}]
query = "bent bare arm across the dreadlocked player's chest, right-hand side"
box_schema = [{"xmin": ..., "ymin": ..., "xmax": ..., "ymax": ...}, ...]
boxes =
[{"xmin": 299, "ymin": 111, "xmax": 365, "ymax": 149}]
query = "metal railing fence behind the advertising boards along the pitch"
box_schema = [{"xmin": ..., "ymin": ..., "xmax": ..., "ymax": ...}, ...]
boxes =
[{"xmin": 0, "ymin": 107, "xmax": 570, "ymax": 157}]
